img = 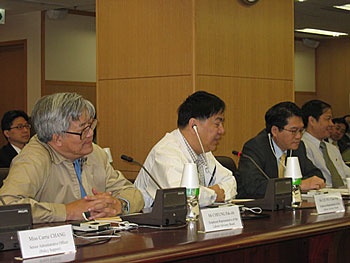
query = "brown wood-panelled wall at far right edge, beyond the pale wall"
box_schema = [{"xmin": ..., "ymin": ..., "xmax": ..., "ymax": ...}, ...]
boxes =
[{"xmin": 316, "ymin": 39, "xmax": 350, "ymax": 117}]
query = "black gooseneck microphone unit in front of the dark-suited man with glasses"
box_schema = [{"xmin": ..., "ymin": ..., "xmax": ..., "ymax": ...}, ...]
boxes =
[{"xmin": 232, "ymin": 151, "xmax": 292, "ymax": 211}]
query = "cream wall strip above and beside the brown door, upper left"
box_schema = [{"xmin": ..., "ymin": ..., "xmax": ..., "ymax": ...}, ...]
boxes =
[{"xmin": 0, "ymin": 12, "xmax": 41, "ymax": 114}]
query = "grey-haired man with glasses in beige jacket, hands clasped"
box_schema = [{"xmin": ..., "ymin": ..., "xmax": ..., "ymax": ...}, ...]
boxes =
[{"xmin": 0, "ymin": 93, "xmax": 144, "ymax": 223}]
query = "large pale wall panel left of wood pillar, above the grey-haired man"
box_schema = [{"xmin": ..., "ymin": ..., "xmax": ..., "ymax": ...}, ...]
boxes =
[{"xmin": 45, "ymin": 14, "xmax": 96, "ymax": 82}]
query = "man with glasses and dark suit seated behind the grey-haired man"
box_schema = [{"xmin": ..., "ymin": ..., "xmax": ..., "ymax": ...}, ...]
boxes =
[{"xmin": 0, "ymin": 110, "xmax": 31, "ymax": 168}]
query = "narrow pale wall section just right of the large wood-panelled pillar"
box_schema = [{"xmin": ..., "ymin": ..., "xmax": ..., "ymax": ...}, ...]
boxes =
[{"xmin": 294, "ymin": 41, "xmax": 316, "ymax": 92}]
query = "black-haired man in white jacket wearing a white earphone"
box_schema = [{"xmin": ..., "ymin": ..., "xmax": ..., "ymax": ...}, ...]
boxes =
[{"xmin": 135, "ymin": 91, "xmax": 236, "ymax": 208}]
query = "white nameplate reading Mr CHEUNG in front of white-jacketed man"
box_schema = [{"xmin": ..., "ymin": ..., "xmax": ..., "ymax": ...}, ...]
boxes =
[{"xmin": 201, "ymin": 205, "xmax": 243, "ymax": 232}]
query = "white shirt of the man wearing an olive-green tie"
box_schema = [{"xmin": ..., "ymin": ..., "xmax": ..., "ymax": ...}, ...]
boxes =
[{"xmin": 302, "ymin": 132, "xmax": 350, "ymax": 187}]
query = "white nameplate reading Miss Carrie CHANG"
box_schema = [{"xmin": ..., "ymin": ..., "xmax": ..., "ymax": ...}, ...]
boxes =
[{"xmin": 17, "ymin": 225, "xmax": 76, "ymax": 259}]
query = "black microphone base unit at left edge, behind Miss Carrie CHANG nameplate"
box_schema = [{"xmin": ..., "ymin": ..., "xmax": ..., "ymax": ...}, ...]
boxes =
[{"xmin": 0, "ymin": 204, "xmax": 32, "ymax": 251}]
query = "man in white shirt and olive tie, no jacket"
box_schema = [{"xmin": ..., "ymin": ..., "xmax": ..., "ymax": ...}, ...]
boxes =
[{"xmin": 302, "ymin": 100, "xmax": 350, "ymax": 188}]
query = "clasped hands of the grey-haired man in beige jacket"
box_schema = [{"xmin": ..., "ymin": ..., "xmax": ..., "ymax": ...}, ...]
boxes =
[{"xmin": 66, "ymin": 188, "xmax": 122, "ymax": 220}]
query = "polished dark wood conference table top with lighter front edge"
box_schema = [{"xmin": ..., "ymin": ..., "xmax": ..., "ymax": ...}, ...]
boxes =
[{"xmin": 0, "ymin": 207, "xmax": 350, "ymax": 262}]
